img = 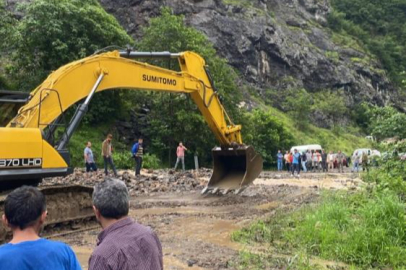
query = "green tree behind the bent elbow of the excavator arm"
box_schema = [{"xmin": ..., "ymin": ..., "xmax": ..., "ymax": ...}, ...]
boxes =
[{"xmin": 134, "ymin": 8, "xmax": 241, "ymax": 165}]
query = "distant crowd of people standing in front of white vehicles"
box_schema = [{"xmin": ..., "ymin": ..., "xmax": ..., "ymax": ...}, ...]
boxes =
[{"xmin": 276, "ymin": 149, "xmax": 369, "ymax": 177}]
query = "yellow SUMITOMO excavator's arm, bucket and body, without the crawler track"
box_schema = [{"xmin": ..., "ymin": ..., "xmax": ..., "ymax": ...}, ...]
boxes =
[{"xmin": 0, "ymin": 51, "xmax": 262, "ymax": 192}]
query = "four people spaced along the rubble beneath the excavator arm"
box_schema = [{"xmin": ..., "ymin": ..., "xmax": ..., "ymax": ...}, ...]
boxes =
[{"xmin": 83, "ymin": 134, "xmax": 187, "ymax": 177}]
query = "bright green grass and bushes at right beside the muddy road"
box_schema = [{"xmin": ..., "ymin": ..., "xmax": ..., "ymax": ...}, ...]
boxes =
[{"xmin": 232, "ymin": 142, "xmax": 406, "ymax": 269}]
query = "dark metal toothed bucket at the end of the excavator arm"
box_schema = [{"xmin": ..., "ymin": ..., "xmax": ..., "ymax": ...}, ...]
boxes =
[{"xmin": 202, "ymin": 146, "xmax": 263, "ymax": 194}]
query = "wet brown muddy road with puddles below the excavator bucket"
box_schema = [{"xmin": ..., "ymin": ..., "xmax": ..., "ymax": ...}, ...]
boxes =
[{"xmin": 47, "ymin": 172, "xmax": 362, "ymax": 270}]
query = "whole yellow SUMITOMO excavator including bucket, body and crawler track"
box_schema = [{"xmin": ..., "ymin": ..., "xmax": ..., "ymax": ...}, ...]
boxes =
[{"xmin": 0, "ymin": 50, "xmax": 262, "ymax": 242}]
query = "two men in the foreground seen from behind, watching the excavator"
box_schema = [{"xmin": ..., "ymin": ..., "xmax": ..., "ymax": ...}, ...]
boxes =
[{"xmin": 0, "ymin": 179, "xmax": 163, "ymax": 270}]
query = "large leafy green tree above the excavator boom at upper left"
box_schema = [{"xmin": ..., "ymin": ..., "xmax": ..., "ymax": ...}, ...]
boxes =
[{"xmin": 9, "ymin": 0, "xmax": 133, "ymax": 123}]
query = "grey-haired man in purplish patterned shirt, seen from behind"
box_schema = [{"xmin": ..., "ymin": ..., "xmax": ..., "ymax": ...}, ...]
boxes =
[{"xmin": 89, "ymin": 179, "xmax": 163, "ymax": 270}]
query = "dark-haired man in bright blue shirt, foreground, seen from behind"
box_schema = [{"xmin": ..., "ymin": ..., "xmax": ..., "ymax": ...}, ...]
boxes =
[{"xmin": 0, "ymin": 186, "xmax": 81, "ymax": 270}]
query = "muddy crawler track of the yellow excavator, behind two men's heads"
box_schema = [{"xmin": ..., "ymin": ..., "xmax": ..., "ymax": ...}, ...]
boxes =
[{"xmin": 0, "ymin": 185, "xmax": 96, "ymax": 243}]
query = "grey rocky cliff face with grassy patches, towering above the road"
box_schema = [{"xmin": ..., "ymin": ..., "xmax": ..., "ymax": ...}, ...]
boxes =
[{"xmin": 100, "ymin": 0, "xmax": 396, "ymax": 110}]
